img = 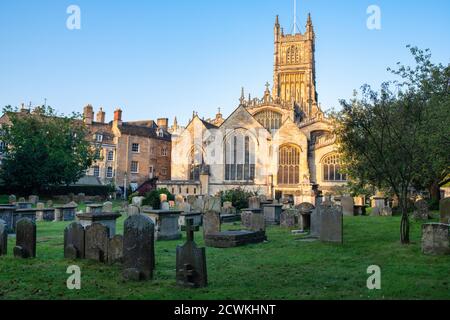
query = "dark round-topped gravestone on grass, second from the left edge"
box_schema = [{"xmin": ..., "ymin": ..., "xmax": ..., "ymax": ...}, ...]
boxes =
[{"xmin": 14, "ymin": 218, "xmax": 36, "ymax": 259}]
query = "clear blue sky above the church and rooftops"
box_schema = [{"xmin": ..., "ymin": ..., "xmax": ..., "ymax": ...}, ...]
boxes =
[{"xmin": 0, "ymin": 0, "xmax": 450, "ymax": 124}]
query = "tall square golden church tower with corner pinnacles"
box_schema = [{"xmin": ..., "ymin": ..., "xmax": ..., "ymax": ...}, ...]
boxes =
[{"xmin": 272, "ymin": 15, "xmax": 320, "ymax": 118}]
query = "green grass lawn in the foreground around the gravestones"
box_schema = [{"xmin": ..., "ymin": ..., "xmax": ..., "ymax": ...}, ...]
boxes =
[{"xmin": 0, "ymin": 205, "xmax": 450, "ymax": 300}]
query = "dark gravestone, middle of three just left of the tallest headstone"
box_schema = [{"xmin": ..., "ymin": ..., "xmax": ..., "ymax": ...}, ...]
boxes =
[{"xmin": 85, "ymin": 223, "xmax": 109, "ymax": 263}]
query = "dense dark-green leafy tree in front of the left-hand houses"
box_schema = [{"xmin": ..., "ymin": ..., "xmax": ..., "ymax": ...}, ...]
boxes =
[{"xmin": 0, "ymin": 107, "xmax": 96, "ymax": 193}]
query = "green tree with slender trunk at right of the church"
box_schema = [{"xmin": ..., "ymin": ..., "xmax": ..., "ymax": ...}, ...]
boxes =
[{"xmin": 335, "ymin": 48, "xmax": 450, "ymax": 244}]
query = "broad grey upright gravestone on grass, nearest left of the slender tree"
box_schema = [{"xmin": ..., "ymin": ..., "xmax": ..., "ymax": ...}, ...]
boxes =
[{"xmin": 318, "ymin": 204, "xmax": 344, "ymax": 243}]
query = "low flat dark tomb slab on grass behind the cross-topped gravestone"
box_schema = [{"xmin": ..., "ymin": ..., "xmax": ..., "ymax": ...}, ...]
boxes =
[{"xmin": 205, "ymin": 230, "xmax": 267, "ymax": 248}]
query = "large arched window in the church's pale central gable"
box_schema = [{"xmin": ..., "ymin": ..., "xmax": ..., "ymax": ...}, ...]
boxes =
[{"xmin": 225, "ymin": 131, "xmax": 256, "ymax": 181}]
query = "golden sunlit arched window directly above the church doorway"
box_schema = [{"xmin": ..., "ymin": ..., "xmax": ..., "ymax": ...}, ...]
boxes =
[{"xmin": 278, "ymin": 145, "xmax": 301, "ymax": 185}]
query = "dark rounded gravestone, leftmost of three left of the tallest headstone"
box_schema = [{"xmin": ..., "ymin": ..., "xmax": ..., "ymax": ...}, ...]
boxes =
[{"xmin": 64, "ymin": 222, "xmax": 85, "ymax": 260}]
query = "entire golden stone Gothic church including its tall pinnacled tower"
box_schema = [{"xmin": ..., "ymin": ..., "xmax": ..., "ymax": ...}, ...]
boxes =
[{"xmin": 159, "ymin": 15, "xmax": 347, "ymax": 203}]
